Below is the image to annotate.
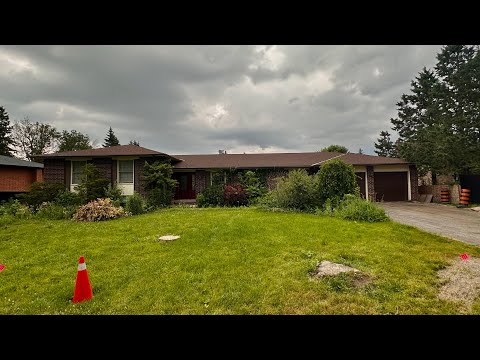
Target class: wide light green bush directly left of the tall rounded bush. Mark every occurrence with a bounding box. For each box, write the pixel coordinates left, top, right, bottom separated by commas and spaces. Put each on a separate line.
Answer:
261, 169, 318, 211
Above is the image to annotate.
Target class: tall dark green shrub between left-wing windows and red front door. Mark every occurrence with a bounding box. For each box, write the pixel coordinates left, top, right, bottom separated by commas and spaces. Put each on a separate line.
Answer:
143, 160, 177, 208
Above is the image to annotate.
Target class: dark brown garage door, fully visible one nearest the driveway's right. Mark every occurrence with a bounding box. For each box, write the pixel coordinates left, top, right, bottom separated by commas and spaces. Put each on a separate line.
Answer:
373, 171, 408, 201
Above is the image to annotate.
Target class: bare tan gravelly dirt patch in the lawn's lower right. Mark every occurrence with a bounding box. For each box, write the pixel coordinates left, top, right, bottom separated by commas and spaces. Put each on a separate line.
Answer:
438, 258, 480, 308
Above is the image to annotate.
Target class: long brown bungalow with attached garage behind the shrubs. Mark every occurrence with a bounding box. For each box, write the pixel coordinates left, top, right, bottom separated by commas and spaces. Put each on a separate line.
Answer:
36, 145, 418, 201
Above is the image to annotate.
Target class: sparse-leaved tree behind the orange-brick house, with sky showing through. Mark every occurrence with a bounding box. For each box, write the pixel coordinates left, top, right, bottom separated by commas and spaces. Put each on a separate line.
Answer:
12, 117, 60, 160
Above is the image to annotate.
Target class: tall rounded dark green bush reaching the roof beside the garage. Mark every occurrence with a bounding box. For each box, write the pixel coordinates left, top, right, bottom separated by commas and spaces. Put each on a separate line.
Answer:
314, 159, 360, 207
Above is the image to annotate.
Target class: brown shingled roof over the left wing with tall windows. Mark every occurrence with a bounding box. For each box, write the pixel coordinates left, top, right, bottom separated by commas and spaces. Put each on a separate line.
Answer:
35, 145, 180, 160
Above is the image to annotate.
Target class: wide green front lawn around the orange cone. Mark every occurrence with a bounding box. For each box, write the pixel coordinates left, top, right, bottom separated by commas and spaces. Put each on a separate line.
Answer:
0, 208, 480, 314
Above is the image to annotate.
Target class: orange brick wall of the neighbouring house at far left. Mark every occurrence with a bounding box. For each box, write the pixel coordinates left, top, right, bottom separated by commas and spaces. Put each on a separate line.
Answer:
0, 166, 42, 192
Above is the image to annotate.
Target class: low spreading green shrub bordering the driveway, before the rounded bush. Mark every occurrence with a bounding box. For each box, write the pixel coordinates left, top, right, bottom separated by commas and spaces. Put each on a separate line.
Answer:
317, 194, 389, 223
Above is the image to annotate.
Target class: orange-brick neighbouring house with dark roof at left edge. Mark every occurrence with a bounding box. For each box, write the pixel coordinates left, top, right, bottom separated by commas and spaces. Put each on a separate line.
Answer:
0, 155, 43, 200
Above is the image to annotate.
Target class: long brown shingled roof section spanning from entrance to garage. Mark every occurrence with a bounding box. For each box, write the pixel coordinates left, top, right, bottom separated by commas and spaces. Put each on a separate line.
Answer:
173, 152, 408, 169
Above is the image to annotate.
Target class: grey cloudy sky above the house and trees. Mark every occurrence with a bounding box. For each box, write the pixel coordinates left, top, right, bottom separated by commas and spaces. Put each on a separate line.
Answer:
0, 45, 441, 154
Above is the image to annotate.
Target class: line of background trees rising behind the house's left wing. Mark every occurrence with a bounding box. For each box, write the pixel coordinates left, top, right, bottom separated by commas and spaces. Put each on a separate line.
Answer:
0, 106, 140, 160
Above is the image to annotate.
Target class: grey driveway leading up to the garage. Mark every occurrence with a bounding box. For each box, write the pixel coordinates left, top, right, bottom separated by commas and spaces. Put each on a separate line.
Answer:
379, 202, 480, 245
